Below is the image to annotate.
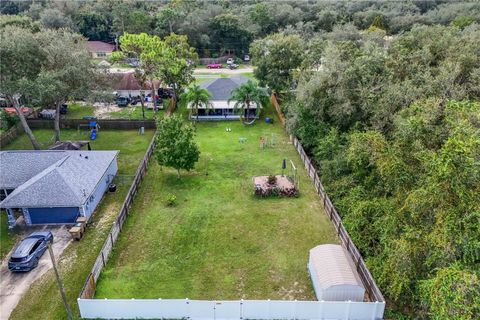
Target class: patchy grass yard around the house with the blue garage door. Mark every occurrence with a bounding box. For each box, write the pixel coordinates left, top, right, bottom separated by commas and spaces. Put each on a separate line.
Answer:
1, 130, 153, 319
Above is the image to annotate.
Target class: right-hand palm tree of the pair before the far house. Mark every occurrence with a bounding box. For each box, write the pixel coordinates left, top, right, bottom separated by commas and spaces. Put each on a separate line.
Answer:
228, 80, 268, 125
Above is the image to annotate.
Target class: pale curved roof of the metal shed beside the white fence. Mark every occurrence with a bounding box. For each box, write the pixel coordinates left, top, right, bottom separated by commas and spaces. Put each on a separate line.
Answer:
310, 244, 363, 289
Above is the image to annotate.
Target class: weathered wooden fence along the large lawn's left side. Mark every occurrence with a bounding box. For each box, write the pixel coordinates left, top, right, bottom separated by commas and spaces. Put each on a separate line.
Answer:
80, 136, 155, 299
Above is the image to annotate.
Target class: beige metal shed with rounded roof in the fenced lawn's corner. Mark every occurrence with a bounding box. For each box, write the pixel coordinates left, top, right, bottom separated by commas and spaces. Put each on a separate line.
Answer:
308, 244, 365, 301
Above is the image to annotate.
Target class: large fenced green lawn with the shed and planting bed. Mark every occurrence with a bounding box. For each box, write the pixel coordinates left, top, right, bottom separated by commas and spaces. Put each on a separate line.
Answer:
96, 107, 338, 299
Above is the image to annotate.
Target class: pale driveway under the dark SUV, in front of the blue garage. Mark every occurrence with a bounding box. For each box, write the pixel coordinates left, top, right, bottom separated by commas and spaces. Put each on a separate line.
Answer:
0, 226, 72, 320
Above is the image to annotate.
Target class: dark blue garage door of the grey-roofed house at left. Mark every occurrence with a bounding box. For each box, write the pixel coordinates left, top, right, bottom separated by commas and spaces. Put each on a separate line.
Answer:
26, 207, 80, 225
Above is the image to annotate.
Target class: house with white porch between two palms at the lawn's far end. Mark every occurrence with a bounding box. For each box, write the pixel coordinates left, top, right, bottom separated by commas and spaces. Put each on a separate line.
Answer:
188, 77, 257, 121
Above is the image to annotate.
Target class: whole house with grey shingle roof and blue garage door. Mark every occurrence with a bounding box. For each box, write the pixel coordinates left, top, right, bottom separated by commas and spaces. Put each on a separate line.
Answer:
0, 150, 118, 227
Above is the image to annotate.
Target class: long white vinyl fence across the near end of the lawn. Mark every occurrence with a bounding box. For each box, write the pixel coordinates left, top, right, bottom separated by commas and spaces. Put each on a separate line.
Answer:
78, 298, 385, 320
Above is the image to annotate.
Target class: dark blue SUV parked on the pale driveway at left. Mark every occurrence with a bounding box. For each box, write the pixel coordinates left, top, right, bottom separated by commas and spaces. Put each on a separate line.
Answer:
8, 231, 53, 272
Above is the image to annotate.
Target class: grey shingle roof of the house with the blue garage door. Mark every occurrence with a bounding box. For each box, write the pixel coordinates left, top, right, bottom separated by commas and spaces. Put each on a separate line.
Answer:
0, 150, 118, 208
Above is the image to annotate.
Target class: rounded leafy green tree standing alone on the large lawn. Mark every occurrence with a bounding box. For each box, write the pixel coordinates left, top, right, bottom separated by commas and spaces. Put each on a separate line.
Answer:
155, 115, 200, 177
